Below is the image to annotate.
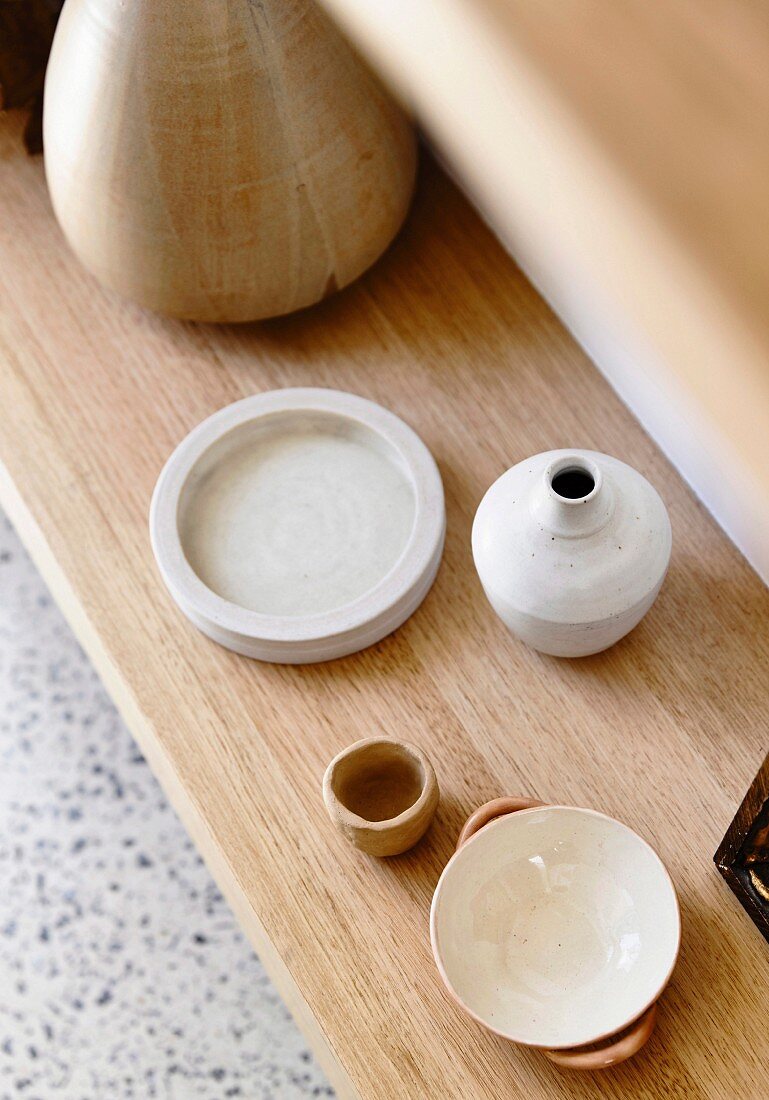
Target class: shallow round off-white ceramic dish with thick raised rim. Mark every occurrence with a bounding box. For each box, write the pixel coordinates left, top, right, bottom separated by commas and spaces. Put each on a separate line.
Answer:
150, 388, 446, 663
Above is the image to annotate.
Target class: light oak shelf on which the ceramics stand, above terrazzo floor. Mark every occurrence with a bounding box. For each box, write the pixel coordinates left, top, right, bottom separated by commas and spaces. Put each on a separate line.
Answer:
0, 109, 769, 1100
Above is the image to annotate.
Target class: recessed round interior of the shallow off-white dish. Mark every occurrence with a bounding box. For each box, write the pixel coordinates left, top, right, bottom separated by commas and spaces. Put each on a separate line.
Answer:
177, 409, 416, 617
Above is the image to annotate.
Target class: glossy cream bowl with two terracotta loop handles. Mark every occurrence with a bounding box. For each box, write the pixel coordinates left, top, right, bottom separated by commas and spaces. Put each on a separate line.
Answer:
430, 799, 681, 1069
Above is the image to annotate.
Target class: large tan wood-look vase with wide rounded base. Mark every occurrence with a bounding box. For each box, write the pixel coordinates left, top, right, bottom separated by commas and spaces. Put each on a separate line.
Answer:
44, 0, 416, 321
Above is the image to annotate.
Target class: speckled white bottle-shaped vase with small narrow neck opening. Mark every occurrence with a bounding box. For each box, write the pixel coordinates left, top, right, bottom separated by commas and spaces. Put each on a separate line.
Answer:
472, 450, 671, 657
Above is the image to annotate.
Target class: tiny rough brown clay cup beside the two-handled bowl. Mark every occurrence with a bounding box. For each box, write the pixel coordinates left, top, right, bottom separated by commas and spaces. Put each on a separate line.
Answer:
323, 737, 439, 856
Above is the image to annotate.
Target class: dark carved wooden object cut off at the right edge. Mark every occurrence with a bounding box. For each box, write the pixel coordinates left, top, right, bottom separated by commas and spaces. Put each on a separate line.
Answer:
713, 756, 769, 939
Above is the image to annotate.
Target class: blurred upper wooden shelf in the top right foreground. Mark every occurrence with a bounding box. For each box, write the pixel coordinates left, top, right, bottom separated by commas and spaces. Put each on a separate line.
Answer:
321, 0, 769, 578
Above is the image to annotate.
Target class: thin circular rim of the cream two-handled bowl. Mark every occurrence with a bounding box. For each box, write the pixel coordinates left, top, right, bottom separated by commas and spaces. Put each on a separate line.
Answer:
430, 803, 681, 1051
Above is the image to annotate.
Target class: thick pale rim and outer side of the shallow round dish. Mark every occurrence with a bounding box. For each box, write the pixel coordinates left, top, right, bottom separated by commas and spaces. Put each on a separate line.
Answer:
150, 386, 446, 662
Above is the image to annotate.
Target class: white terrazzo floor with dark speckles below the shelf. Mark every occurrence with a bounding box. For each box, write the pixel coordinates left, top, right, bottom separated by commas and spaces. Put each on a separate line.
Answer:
0, 514, 333, 1100
